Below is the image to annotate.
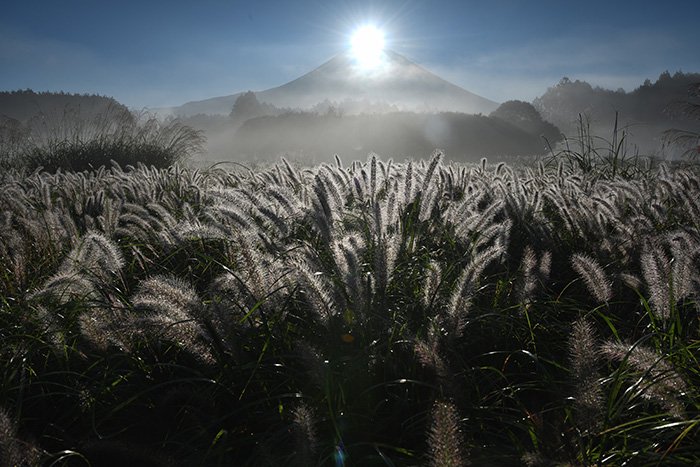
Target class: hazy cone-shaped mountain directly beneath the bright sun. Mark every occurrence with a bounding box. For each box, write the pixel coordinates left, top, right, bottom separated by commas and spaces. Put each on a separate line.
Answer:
162, 51, 498, 117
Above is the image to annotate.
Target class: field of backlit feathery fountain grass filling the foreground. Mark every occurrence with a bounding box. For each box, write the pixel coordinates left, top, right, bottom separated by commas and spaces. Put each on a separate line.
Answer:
0, 154, 700, 466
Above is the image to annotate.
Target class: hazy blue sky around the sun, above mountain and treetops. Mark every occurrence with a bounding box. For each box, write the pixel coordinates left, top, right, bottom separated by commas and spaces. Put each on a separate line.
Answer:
0, 0, 700, 108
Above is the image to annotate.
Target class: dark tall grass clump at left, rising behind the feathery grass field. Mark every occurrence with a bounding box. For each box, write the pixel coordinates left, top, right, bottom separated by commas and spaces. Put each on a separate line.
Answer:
0, 107, 204, 172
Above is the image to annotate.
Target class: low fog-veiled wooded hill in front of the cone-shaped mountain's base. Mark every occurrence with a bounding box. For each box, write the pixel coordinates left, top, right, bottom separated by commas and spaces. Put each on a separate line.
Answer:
201, 102, 559, 163
